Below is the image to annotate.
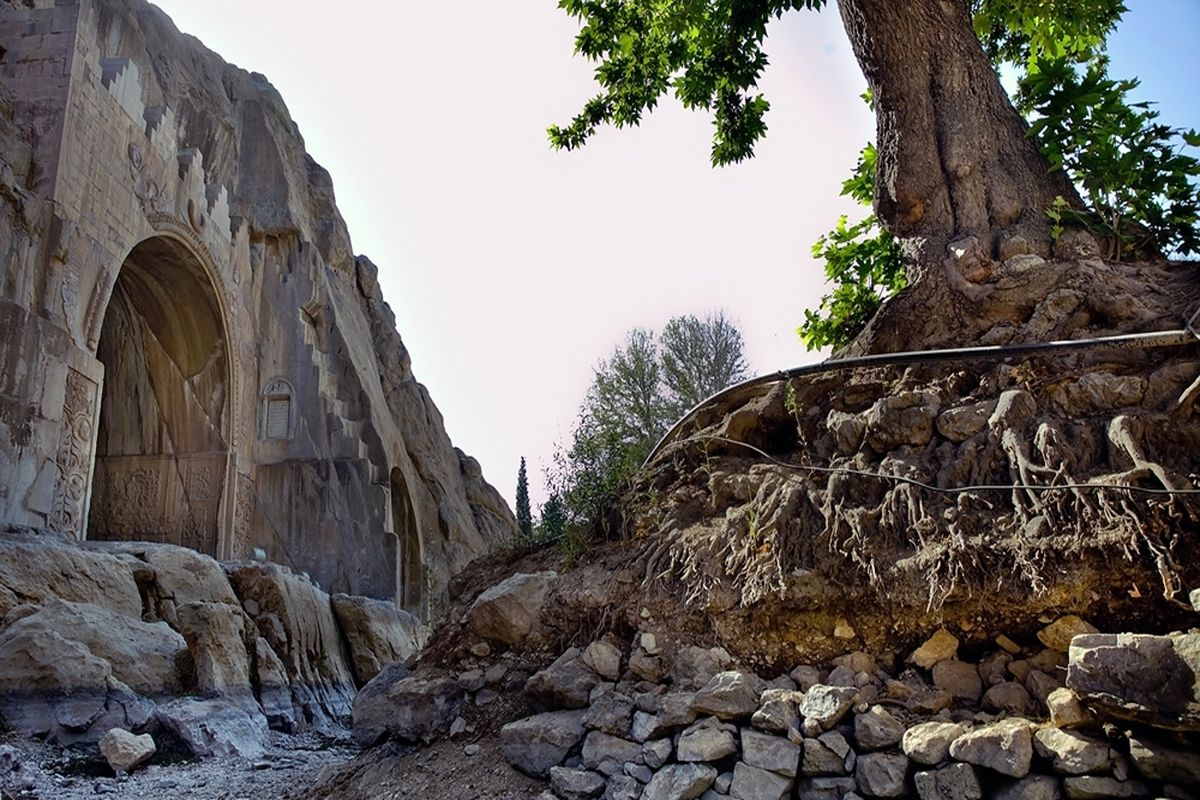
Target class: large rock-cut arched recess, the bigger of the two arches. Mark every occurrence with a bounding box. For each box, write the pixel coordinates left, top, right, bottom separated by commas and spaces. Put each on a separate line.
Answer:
88, 235, 232, 557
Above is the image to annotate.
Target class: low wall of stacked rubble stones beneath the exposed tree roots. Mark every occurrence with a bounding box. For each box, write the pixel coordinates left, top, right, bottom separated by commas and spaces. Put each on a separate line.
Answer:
354, 581, 1200, 800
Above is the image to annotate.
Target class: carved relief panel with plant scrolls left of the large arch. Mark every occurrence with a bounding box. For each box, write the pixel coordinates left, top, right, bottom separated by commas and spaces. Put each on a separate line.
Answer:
50, 369, 98, 539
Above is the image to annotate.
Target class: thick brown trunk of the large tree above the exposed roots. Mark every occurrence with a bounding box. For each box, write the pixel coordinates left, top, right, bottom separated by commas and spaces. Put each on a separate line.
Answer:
839, 0, 1076, 261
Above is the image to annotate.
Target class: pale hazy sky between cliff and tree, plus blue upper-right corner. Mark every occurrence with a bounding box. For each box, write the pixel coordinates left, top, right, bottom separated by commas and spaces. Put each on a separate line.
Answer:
157, 0, 1200, 513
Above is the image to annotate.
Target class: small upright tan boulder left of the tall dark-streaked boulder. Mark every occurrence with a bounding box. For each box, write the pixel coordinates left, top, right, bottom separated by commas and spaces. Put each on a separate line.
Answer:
175, 601, 258, 697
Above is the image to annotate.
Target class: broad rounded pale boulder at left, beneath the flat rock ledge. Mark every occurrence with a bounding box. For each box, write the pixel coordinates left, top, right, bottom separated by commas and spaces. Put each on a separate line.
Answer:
0, 597, 187, 697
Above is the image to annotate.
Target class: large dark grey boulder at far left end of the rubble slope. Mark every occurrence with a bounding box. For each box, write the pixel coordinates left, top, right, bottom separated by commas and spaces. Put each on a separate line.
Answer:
352, 670, 466, 746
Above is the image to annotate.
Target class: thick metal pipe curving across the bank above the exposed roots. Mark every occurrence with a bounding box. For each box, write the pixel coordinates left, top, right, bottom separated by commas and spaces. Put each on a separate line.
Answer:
642, 326, 1200, 469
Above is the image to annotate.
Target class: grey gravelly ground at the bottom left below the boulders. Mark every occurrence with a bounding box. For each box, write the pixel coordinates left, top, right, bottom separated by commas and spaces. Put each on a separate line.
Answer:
0, 732, 360, 800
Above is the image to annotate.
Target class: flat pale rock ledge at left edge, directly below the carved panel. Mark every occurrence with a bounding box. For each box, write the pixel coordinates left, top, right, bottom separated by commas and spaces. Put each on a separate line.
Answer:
0, 529, 142, 619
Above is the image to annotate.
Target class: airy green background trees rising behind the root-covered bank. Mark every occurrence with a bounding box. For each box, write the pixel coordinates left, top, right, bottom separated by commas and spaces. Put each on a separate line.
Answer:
544, 312, 748, 533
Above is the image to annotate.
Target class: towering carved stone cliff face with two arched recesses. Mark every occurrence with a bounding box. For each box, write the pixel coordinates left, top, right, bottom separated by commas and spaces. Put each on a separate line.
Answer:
0, 0, 515, 610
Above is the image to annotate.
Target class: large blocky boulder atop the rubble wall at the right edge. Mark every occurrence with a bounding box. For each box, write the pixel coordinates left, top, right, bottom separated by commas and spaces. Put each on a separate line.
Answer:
1067, 633, 1200, 730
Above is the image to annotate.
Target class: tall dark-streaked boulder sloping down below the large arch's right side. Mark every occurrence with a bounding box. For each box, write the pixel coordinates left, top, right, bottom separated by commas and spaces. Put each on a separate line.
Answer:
224, 563, 355, 728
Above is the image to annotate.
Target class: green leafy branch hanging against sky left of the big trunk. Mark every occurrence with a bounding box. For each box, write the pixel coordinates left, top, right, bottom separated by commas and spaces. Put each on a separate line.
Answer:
548, 0, 824, 164
